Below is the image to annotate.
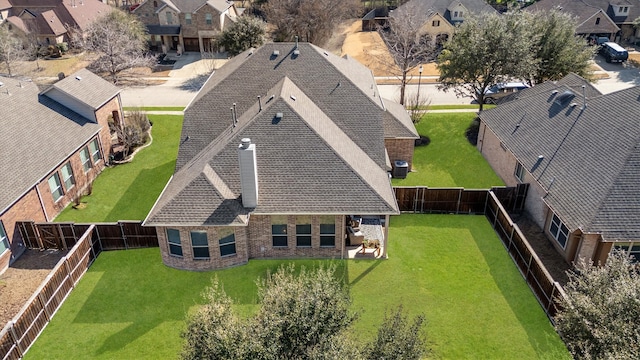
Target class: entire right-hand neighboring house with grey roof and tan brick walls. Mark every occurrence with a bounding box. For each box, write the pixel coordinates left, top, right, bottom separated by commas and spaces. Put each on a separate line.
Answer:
477, 74, 640, 263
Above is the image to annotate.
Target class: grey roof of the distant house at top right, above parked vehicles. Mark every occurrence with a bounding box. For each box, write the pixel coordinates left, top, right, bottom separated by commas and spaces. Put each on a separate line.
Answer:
525, 0, 624, 34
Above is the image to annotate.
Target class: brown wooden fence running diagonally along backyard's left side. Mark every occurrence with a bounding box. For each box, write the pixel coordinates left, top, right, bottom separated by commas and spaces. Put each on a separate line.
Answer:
0, 225, 98, 360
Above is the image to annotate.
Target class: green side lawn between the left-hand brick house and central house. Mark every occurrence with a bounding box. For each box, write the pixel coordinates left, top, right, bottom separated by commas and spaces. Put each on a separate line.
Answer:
55, 115, 182, 222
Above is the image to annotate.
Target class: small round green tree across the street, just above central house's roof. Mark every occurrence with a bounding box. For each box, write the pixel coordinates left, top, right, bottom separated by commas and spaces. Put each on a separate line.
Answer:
220, 16, 266, 56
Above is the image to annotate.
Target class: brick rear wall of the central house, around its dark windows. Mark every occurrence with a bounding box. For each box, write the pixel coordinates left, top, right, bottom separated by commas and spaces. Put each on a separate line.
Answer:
156, 215, 345, 271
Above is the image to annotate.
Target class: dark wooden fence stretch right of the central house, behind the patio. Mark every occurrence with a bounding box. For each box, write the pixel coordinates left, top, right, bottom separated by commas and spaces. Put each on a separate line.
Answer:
393, 184, 528, 214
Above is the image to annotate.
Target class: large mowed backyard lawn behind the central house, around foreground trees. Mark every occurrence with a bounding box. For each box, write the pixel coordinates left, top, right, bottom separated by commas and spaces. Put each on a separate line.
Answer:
25, 215, 570, 359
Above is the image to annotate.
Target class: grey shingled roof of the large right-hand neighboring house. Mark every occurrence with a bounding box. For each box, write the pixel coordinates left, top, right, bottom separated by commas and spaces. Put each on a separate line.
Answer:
480, 74, 640, 241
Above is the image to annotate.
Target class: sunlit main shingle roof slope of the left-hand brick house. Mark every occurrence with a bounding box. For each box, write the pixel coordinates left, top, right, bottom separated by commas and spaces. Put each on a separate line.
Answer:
0, 71, 117, 213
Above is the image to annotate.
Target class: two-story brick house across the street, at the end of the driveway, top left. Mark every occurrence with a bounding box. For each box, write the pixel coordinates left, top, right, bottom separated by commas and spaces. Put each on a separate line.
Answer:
133, 0, 239, 52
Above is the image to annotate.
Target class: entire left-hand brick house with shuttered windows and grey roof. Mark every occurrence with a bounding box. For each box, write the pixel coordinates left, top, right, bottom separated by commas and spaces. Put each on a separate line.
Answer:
0, 70, 122, 272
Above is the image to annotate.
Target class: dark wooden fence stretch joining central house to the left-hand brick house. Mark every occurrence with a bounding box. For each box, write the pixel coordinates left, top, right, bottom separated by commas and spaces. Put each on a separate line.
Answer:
16, 221, 158, 252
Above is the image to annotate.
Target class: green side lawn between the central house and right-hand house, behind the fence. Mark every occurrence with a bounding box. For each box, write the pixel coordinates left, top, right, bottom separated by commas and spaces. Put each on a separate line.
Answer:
392, 112, 504, 189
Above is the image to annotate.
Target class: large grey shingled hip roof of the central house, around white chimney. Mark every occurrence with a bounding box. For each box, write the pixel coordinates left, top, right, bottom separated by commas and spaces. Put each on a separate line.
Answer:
145, 43, 408, 226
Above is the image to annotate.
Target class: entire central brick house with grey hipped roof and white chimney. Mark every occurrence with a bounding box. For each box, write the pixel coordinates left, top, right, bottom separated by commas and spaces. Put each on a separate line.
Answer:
144, 43, 418, 270
